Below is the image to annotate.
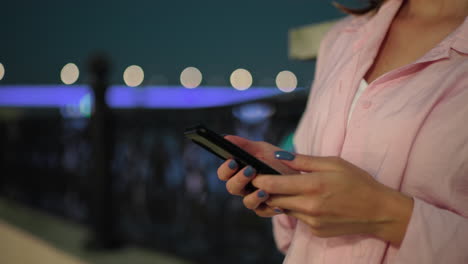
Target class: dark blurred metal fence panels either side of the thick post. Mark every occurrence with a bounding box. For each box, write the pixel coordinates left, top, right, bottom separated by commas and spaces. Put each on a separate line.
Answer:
0, 93, 305, 263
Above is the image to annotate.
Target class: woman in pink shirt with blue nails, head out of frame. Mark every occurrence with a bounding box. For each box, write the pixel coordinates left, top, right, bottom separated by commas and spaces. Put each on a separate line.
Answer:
218, 0, 468, 263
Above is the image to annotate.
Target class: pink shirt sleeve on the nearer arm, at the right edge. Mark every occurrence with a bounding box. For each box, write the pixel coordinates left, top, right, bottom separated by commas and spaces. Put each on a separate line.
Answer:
394, 75, 468, 264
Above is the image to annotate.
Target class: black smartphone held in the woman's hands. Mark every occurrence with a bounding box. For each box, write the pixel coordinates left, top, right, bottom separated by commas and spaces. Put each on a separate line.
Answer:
184, 125, 281, 191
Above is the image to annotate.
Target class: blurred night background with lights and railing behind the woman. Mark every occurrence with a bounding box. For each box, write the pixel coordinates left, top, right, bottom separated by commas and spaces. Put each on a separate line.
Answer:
0, 0, 343, 263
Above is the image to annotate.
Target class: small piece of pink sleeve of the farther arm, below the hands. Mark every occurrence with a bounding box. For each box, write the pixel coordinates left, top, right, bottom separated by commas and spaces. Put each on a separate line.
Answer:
273, 214, 297, 254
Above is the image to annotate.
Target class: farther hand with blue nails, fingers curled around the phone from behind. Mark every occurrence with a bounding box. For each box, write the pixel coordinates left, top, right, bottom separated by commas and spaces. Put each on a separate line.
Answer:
218, 136, 298, 217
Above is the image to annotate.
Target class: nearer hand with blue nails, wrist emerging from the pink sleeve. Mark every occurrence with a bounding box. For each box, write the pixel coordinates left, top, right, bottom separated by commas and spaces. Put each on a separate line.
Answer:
252, 151, 413, 246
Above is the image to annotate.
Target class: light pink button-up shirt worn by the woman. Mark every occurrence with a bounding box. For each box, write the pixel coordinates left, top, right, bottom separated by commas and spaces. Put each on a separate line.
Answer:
273, 0, 468, 264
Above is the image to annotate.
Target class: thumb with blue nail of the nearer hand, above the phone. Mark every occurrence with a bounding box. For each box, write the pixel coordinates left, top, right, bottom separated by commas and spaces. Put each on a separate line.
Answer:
275, 151, 339, 172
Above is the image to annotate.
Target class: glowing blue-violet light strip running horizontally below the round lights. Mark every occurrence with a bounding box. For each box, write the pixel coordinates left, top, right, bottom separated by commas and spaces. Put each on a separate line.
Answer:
0, 85, 283, 109
